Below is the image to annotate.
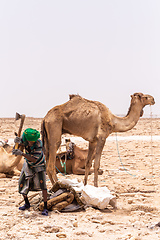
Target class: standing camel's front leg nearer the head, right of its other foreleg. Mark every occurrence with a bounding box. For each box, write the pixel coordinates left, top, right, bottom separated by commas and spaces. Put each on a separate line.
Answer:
94, 138, 106, 187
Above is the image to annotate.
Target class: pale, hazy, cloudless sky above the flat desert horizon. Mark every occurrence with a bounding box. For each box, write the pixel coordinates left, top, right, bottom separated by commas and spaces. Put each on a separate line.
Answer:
0, 0, 160, 117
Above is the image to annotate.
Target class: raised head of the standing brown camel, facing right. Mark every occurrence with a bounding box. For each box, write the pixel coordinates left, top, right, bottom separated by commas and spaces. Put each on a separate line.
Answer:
127, 93, 155, 117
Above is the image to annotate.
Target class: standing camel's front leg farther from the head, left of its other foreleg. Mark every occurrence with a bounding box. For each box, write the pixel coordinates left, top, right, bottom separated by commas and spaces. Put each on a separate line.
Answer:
84, 142, 97, 185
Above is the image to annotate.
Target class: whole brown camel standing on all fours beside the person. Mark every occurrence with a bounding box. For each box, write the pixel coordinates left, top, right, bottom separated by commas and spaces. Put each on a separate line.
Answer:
41, 93, 155, 187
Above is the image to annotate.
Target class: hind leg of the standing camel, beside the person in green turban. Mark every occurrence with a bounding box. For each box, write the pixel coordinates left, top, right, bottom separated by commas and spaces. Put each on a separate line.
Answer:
46, 121, 62, 184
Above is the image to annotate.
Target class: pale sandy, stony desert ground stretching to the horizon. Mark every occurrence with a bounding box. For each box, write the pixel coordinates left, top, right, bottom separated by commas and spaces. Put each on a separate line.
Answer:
0, 117, 160, 240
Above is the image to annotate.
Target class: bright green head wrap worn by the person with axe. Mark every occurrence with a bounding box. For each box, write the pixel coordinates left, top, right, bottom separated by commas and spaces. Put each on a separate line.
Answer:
22, 128, 40, 142
